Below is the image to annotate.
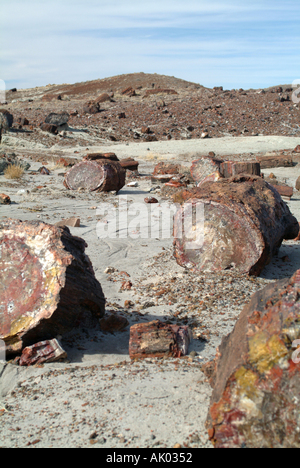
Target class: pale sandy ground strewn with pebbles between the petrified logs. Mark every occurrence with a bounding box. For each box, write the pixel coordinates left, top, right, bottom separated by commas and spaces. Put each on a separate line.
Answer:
0, 133, 300, 448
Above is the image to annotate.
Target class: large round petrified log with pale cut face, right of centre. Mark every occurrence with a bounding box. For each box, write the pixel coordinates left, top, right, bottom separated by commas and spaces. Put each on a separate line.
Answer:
174, 174, 299, 276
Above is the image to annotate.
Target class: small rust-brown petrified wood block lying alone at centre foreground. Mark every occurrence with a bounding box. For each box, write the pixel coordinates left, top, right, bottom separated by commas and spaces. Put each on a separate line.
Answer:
129, 320, 192, 359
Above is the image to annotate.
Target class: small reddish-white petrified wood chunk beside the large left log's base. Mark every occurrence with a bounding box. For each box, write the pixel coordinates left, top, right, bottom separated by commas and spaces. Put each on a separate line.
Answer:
19, 339, 68, 366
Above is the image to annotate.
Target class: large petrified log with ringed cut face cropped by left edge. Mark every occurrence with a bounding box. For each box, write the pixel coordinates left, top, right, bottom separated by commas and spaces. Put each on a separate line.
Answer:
0, 219, 105, 354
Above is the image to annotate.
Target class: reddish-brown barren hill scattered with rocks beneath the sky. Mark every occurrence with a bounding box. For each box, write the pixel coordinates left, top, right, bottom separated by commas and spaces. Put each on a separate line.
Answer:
3, 73, 300, 151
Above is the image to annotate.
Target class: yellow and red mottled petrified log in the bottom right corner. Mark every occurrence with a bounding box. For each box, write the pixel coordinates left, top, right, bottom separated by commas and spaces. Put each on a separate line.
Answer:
206, 270, 300, 448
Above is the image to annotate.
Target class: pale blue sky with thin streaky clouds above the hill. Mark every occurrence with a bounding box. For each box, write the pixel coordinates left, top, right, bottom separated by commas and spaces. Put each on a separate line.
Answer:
0, 0, 300, 89
